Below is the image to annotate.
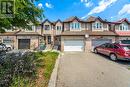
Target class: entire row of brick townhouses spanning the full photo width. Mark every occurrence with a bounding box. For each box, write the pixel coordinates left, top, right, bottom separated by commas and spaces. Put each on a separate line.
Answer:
0, 16, 130, 51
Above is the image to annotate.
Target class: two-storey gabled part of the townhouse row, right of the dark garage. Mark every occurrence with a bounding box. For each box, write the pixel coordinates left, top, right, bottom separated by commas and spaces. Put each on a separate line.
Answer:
42, 16, 130, 51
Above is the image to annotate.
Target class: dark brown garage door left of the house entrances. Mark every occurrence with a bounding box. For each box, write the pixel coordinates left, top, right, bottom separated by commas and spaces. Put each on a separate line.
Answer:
18, 39, 30, 49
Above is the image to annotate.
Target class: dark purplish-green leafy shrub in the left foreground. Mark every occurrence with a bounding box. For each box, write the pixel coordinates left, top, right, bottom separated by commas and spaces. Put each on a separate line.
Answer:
0, 52, 43, 87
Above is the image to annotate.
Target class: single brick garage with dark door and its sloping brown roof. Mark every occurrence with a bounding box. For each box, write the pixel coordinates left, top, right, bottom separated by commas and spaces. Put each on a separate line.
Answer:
16, 31, 41, 50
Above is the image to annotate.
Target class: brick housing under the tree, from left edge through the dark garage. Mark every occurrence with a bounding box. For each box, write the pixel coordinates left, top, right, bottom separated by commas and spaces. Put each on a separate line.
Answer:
0, 25, 42, 49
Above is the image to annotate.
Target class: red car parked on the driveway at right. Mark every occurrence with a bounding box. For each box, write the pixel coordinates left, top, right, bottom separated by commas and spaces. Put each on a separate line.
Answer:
94, 43, 130, 61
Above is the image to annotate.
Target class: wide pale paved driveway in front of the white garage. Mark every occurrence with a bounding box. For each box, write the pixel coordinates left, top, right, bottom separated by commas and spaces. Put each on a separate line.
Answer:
57, 52, 130, 87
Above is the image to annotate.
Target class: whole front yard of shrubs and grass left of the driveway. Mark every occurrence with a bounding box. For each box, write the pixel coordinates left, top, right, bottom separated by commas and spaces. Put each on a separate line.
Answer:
0, 51, 59, 87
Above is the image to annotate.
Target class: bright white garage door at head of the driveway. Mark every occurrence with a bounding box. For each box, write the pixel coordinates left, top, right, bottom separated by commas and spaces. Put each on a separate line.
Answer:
64, 40, 84, 51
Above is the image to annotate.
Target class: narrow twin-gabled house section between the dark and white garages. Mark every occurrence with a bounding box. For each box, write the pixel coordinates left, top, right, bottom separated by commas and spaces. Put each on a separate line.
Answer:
42, 19, 63, 45
